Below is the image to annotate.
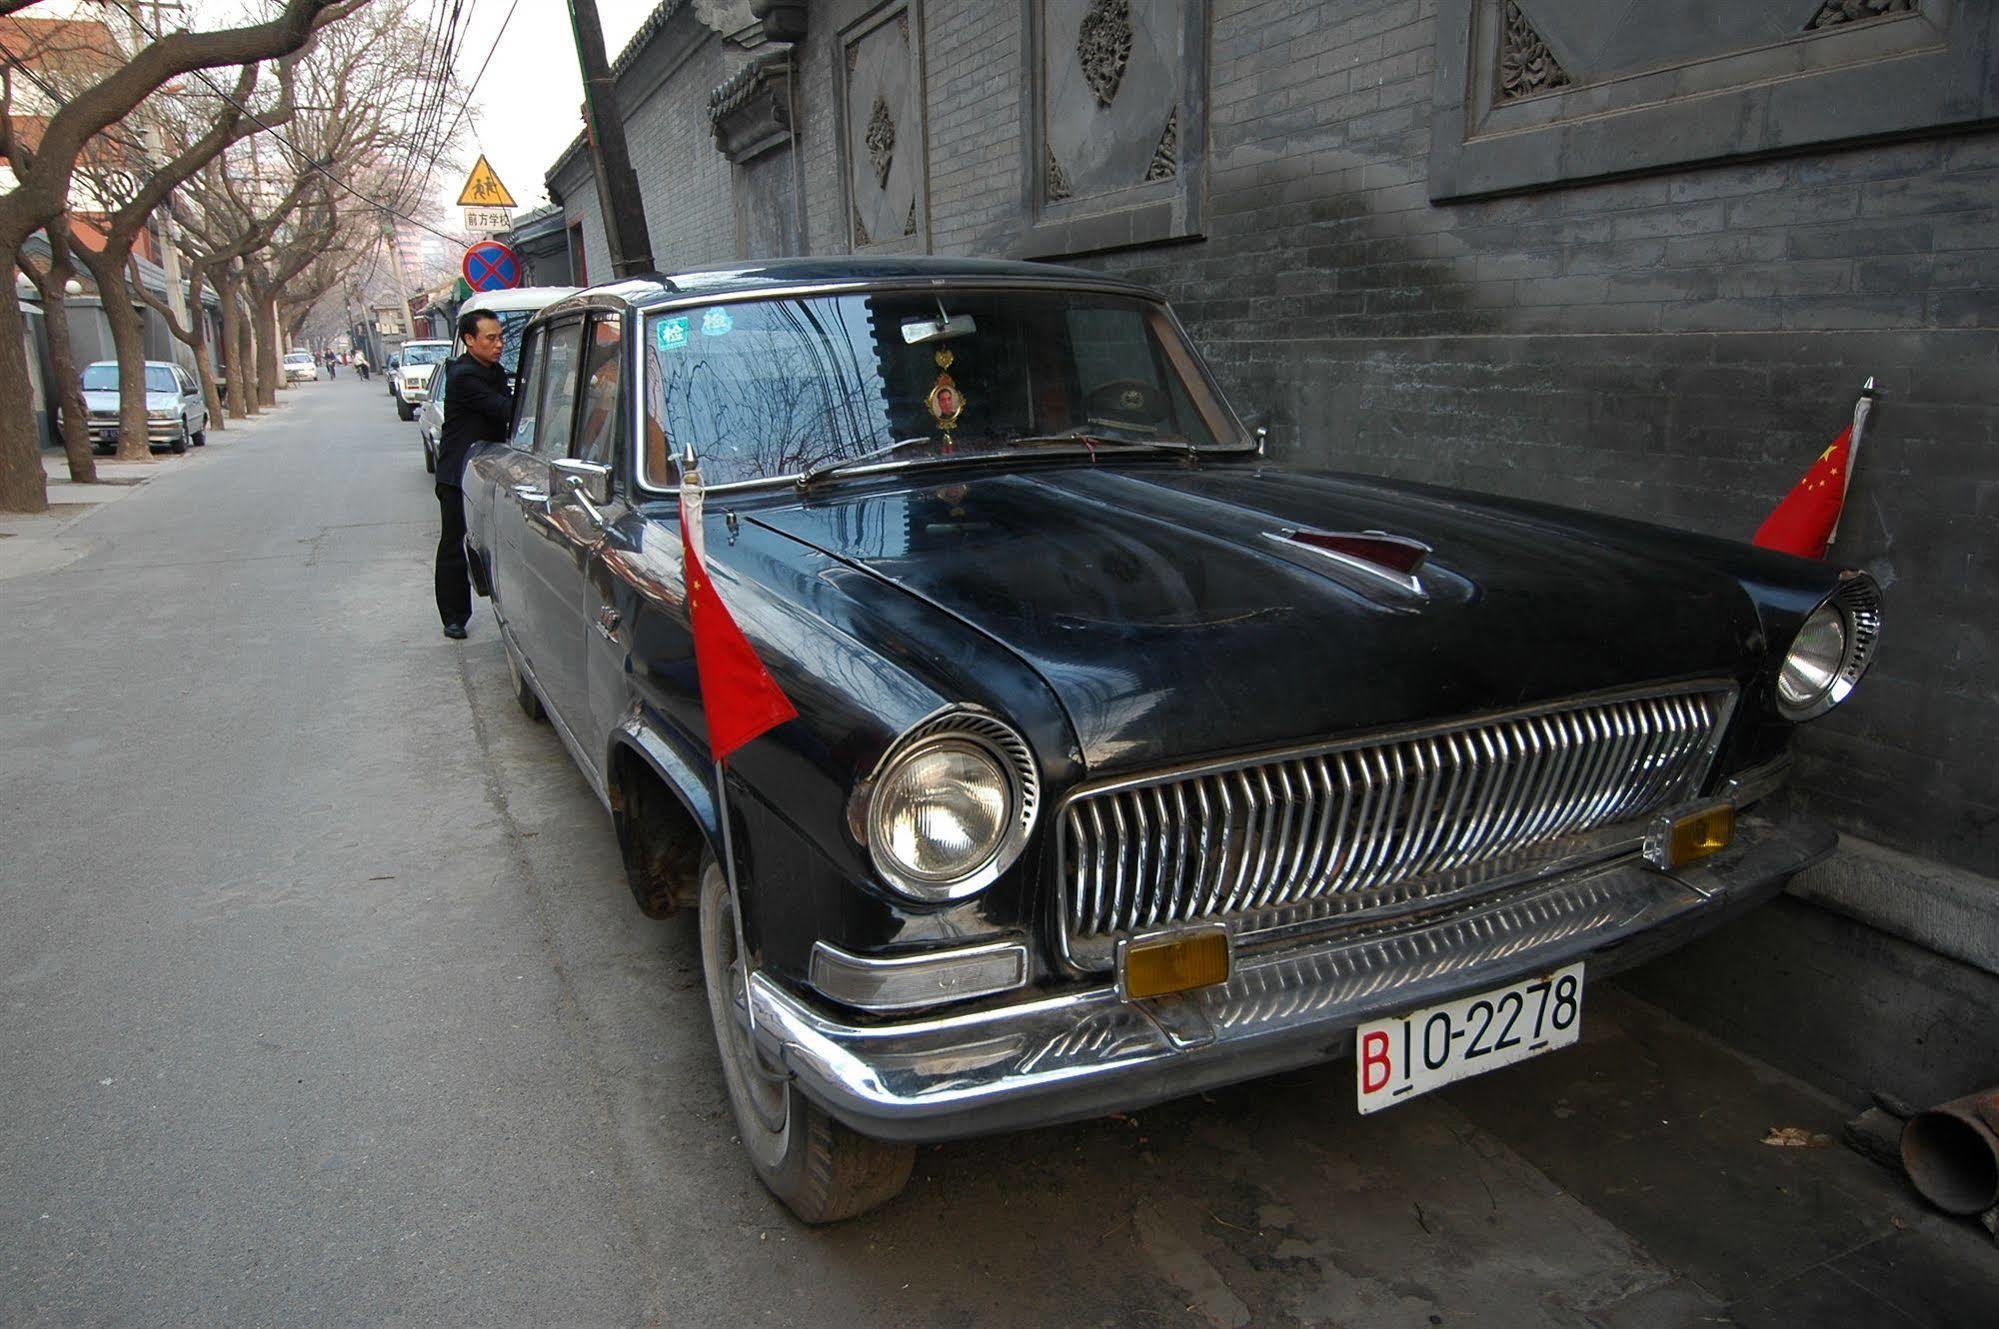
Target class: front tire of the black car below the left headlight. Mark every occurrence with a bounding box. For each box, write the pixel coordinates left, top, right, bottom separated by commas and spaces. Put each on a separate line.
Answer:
700, 855, 916, 1223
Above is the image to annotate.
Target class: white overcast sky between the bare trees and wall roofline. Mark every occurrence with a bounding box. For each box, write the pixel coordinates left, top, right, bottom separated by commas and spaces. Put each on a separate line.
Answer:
433, 0, 660, 228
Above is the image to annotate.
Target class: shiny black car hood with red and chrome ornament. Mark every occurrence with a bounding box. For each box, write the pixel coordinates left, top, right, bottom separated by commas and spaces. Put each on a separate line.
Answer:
756, 466, 1759, 771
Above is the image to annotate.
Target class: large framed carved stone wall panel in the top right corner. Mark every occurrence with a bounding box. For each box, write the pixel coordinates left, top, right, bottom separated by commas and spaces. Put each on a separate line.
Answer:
1427, 0, 1999, 202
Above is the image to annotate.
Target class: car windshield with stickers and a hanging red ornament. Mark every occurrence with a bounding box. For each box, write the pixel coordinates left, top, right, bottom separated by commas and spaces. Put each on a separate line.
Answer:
644, 290, 1243, 488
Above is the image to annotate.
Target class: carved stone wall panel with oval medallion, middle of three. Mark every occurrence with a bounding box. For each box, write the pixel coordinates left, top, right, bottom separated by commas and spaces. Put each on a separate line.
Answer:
1037, 0, 1189, 200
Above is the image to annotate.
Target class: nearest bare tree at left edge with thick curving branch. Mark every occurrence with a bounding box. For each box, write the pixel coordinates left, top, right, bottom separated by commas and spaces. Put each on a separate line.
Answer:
0, 0, 368, 512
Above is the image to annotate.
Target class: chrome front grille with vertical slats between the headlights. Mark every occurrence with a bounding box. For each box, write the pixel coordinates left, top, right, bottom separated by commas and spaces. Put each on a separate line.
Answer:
1057, 685, 1735, 963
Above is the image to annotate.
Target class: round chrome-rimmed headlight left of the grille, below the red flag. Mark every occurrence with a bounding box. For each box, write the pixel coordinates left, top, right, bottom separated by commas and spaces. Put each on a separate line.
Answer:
854, 711, 1039, 901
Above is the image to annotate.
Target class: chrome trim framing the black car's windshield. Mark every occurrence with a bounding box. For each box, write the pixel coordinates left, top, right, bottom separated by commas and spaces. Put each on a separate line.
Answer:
623, 276, 1259, 502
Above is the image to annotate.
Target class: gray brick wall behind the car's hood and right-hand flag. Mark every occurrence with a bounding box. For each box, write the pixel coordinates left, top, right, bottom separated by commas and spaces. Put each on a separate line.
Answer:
1075, 0, 1999, 875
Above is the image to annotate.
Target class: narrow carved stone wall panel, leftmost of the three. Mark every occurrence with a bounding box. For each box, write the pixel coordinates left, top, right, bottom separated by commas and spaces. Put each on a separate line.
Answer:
842, 6, 928, 250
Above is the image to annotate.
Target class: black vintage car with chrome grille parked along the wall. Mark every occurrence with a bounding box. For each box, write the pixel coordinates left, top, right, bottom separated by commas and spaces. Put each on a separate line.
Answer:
466, 260, 1879, 1221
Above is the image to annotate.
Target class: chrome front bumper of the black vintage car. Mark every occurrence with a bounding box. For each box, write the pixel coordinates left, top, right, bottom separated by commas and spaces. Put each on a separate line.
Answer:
750, 813, 1837, 1141
